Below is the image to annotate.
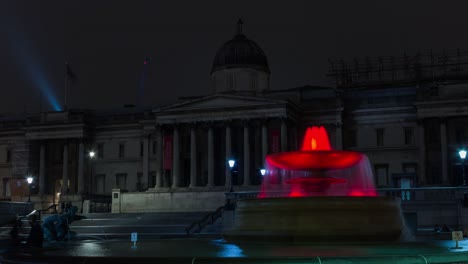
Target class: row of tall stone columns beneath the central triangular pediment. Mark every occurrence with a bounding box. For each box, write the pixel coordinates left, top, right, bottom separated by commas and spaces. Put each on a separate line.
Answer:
155, 119, 288, 188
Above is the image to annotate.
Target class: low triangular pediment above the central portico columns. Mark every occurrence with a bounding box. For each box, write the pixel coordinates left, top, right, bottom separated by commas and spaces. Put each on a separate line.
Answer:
155, 95, 286, 112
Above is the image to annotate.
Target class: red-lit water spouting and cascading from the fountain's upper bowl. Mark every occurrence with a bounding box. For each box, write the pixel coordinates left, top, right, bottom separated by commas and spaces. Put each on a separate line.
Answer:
259, 127, 377, 198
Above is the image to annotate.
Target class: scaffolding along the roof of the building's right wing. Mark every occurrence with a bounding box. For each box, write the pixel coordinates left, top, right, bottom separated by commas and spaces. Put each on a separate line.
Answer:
327, 49, 468, 88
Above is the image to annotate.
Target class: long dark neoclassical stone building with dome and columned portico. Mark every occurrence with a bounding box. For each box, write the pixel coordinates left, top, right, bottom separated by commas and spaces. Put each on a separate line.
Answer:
0, 23, 468, 226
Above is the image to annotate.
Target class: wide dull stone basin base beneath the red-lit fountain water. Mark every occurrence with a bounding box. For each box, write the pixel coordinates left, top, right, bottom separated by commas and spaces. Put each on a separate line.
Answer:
223, 196, 404, 242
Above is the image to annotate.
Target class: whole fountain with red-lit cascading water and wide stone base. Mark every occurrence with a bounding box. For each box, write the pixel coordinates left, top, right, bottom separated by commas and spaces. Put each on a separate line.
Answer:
224, 127, 404, 242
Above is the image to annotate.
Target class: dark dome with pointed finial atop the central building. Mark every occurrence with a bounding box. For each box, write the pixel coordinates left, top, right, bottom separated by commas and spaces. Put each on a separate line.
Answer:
211, 19, 270, 73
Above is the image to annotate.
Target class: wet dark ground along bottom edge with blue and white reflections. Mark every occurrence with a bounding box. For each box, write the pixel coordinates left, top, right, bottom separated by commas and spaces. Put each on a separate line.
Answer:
2, 237, 468, 263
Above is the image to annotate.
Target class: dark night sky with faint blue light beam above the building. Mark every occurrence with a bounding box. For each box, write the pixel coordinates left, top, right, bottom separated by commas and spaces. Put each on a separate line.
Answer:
0, 0, 468, 113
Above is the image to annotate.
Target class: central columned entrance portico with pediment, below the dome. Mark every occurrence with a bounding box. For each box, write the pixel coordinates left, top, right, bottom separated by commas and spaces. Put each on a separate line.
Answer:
154, 95, 295, 193
